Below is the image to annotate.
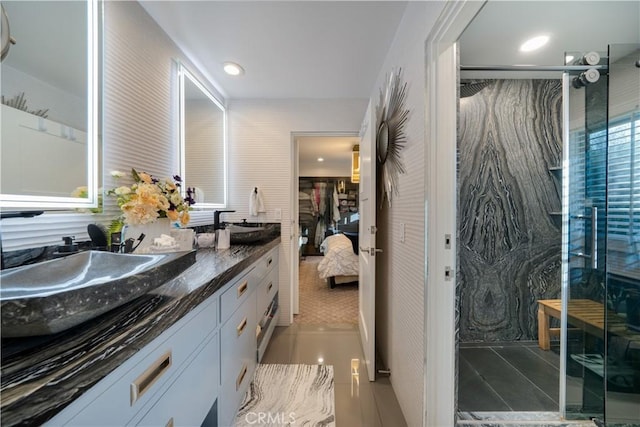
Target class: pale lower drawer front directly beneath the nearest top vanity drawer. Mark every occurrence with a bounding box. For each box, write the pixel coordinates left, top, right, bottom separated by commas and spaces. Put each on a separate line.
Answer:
136, 333, 220, 427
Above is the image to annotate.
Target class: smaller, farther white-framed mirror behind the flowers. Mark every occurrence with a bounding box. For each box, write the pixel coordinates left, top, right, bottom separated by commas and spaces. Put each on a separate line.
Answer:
179, 65, 227, 208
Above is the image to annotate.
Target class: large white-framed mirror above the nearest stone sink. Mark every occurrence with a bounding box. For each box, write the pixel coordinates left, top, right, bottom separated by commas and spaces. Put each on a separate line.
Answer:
0, 0, 98, 208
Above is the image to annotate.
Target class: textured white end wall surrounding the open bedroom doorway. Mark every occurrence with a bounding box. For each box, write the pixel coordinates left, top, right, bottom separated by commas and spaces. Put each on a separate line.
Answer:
227, 99, 367, 325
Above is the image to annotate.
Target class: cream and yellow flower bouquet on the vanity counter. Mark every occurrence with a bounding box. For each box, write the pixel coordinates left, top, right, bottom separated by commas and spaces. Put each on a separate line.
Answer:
107, 169, 195, 226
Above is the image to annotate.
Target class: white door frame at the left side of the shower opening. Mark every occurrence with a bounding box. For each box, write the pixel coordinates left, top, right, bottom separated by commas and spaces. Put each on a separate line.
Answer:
423, 0, 485, 426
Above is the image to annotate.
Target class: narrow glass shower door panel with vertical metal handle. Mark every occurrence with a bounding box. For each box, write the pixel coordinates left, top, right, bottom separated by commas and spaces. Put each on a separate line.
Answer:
562, 54, 608, 419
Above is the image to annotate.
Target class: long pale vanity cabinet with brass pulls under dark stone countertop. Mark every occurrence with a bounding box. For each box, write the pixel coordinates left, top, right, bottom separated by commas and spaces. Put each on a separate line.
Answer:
41, 246, 279, 427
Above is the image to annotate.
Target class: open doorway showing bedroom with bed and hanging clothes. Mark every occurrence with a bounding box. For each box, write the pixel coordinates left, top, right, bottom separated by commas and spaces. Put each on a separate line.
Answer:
293, 133, 359, 325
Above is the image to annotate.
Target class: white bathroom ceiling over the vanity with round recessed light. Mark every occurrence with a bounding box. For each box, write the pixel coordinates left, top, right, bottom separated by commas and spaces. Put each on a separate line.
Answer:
140, 0, 407, 99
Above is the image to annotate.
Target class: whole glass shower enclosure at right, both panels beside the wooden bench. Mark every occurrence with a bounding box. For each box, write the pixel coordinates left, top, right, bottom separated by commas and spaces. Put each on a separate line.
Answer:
558, 44, 640, 426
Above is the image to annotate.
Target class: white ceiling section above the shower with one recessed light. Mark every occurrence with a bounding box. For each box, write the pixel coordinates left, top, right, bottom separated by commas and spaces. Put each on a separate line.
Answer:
460, 0, 640, 78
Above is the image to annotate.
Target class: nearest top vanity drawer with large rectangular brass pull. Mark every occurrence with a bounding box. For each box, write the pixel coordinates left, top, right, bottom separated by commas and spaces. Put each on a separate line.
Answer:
50, 297, 217, 426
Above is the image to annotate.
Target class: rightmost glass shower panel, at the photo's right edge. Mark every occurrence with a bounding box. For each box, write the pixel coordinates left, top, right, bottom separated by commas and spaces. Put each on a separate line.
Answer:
604, 45, 640, 426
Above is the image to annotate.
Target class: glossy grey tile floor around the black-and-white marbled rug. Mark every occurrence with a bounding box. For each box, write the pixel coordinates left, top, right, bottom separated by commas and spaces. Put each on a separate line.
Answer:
261, 324, 406, 427
